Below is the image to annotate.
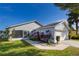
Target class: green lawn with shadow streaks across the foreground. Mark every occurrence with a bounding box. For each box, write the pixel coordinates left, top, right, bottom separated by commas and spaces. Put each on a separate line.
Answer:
0, 41, 79, 56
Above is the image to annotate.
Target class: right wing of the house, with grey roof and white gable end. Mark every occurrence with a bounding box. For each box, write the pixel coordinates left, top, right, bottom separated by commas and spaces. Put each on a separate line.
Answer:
35, 21, 68, 43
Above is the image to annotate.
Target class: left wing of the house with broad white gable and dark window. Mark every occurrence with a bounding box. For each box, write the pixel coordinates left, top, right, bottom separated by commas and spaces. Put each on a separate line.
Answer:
7, 21, 42, 40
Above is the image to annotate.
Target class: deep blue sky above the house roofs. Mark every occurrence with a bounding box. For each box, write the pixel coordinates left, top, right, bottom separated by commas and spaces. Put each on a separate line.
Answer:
0, 3, 67, 30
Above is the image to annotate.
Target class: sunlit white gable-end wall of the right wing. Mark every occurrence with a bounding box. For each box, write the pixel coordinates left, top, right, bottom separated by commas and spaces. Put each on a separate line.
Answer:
54, 23, 68, 42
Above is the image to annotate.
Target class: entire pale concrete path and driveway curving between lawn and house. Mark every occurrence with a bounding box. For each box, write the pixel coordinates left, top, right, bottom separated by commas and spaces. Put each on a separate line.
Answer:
25, 39, 79, 50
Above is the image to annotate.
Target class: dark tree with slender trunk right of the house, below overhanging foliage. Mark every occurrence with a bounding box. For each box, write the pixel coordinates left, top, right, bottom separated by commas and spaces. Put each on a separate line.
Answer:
68, 12, 79, 35
